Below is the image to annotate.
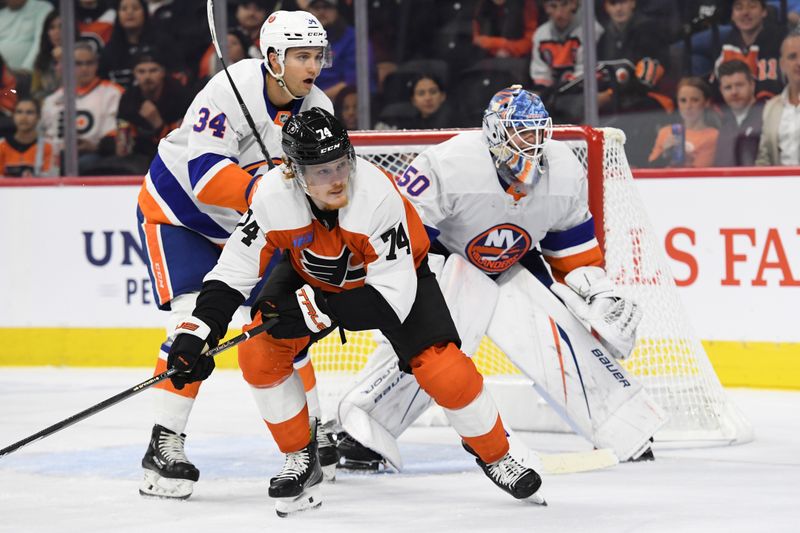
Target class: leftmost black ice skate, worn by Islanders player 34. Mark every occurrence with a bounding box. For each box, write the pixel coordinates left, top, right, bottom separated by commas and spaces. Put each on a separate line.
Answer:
139, 424, 200, 500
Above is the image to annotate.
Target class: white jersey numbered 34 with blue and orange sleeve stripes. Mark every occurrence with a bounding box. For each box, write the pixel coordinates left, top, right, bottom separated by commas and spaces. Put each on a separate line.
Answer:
139, 59, 333, 244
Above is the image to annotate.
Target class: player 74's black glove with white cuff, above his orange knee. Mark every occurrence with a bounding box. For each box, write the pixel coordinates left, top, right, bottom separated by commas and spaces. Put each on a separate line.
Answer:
260, 284, 334, 339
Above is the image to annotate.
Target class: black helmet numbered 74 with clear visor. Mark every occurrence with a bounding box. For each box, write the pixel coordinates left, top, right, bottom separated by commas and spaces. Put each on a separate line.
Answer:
281, 107, 356, 194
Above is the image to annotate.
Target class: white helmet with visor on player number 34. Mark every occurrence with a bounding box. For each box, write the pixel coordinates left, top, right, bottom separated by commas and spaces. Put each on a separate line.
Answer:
259, 11, 331, 83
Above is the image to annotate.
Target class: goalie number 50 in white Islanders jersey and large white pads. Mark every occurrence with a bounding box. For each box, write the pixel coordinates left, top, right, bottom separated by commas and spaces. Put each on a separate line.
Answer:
339, 85, 665, 469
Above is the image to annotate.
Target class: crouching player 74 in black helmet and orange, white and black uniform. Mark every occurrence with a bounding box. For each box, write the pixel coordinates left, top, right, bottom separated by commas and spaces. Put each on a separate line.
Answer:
169, 108, 543, 516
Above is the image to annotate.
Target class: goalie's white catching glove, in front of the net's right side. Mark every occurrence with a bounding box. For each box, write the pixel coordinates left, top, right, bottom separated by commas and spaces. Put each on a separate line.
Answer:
551, 267, 642, 359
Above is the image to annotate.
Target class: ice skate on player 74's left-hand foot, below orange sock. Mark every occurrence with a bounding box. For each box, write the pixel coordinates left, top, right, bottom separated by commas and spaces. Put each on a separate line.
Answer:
269, 419, 322, 518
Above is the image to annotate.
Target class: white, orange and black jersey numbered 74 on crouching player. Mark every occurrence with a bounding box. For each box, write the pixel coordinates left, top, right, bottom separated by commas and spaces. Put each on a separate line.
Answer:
204, 158, 430, 321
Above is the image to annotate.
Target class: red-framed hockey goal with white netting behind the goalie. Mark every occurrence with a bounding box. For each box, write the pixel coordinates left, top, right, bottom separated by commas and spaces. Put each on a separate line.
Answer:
311, 126, 752, 445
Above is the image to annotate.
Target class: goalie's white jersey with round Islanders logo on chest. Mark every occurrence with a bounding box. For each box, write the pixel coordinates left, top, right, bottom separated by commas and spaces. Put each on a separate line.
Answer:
406, 132, 602, 277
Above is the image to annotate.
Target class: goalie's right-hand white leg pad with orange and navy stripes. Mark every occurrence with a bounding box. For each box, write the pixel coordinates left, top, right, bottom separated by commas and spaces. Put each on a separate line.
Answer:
488, 266, 667, 461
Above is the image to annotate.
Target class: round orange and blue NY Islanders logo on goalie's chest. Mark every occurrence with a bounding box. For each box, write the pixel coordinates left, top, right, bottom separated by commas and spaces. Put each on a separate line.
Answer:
465, 224, 531, 274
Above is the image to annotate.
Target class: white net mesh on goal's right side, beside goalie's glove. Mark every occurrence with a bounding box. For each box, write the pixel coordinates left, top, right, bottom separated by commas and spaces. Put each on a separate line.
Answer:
603, 130, 751, 442
